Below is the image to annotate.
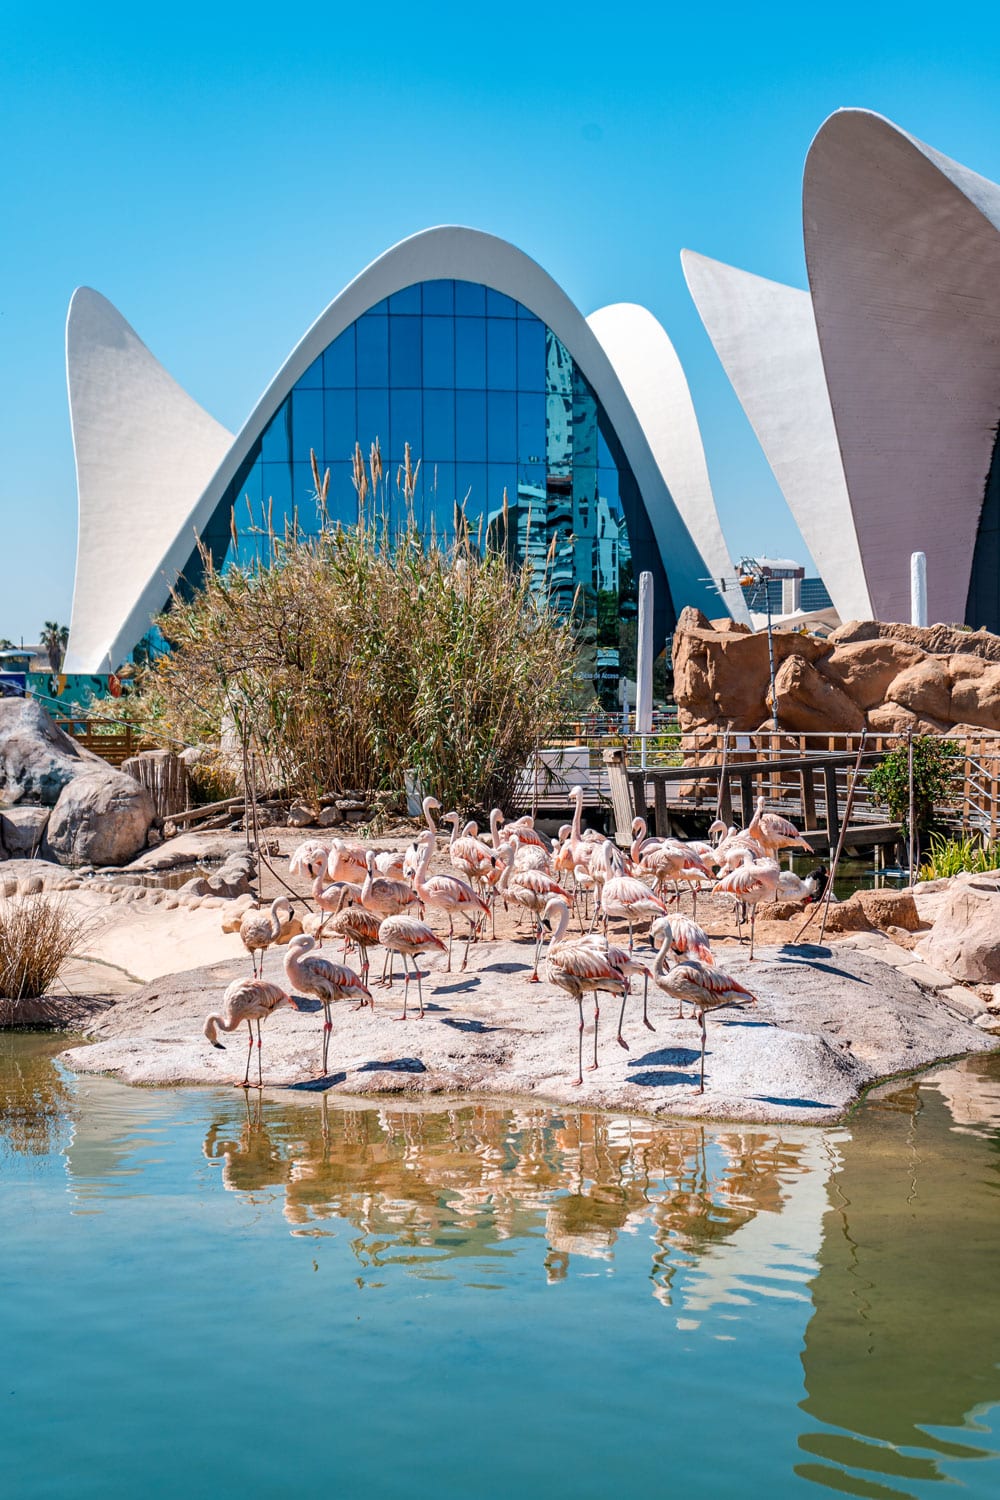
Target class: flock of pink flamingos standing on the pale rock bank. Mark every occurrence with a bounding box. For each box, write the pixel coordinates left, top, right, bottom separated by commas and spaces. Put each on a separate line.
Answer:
205, 788, 828, 1092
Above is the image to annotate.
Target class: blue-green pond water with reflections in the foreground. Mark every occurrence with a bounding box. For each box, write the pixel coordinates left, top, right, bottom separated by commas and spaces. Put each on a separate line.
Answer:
0, 1034, 1000, 1500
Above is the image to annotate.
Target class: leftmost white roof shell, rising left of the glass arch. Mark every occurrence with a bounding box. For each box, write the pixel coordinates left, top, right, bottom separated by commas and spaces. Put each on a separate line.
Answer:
64, 287, 232, 672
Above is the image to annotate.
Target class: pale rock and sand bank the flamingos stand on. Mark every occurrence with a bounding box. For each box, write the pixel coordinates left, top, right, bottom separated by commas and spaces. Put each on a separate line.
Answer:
3, 830, 997, 1124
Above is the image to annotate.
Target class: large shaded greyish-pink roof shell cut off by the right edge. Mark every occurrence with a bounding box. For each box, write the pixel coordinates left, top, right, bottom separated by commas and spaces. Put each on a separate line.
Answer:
802, 110, 1000, 621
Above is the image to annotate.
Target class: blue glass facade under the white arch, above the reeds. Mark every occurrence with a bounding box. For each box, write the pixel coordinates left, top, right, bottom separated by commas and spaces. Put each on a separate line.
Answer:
184, 281, 675, 707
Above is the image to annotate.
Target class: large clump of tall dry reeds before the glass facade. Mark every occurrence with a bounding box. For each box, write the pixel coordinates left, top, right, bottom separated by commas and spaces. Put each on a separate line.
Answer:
111, 446, 574, 807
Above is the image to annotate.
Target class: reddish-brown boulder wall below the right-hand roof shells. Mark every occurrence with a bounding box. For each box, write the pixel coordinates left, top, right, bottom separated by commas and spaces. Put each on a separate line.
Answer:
673, 608, 1000, 735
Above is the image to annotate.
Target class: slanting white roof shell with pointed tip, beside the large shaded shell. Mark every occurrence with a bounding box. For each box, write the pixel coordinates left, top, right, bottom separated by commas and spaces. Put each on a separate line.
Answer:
681, 251, 871, 620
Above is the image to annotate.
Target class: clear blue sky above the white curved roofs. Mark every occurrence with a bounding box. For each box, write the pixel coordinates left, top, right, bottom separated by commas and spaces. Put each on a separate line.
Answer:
0, 0, 1000, 639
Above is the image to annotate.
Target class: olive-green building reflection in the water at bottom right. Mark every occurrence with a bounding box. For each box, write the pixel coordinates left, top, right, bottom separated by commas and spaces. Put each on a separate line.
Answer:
798, 1059, 1000, 1496
